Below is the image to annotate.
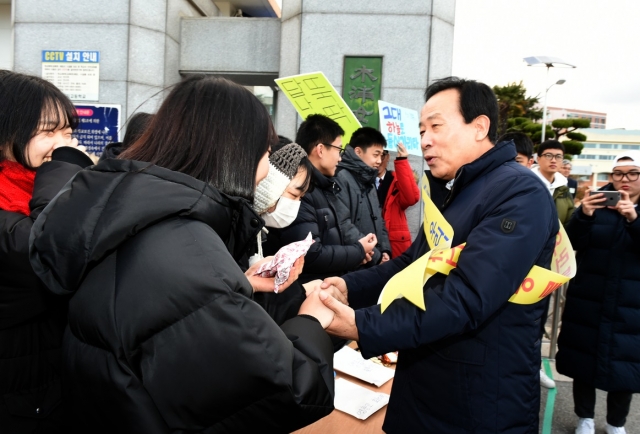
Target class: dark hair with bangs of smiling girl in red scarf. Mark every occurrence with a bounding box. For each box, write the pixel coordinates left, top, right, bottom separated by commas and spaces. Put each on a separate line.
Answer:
0, 70, 78, 169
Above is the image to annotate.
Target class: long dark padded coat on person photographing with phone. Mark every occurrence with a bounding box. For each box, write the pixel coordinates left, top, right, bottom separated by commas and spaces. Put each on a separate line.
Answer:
557, 184, 640, 393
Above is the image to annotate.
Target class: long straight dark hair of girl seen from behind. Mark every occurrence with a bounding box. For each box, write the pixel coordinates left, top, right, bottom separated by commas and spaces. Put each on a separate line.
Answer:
118, 76, 278, 201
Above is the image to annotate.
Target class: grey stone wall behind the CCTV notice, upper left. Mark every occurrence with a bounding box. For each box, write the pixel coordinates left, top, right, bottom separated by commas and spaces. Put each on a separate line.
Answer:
13, 0, 217, 123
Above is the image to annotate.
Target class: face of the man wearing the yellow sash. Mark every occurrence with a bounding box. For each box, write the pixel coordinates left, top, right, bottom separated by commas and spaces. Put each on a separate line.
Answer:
420, 89, 486, 181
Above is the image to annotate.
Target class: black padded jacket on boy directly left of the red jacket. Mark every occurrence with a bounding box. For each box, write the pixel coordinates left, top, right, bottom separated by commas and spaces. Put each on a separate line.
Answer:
336, 146, 391, 266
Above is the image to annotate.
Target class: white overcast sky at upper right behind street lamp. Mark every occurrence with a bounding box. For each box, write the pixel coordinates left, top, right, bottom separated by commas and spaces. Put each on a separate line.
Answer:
452, 0, 640, 130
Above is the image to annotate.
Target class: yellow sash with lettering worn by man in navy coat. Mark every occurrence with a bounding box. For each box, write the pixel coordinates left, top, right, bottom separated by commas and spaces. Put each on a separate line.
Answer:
378, 175, 577, 312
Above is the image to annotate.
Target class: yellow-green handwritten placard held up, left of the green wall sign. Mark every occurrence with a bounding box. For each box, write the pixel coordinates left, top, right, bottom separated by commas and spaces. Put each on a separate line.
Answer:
275, 72, 362, 146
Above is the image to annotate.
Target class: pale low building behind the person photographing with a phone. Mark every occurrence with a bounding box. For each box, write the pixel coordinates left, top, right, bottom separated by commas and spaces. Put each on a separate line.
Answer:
571, 124, 640, 187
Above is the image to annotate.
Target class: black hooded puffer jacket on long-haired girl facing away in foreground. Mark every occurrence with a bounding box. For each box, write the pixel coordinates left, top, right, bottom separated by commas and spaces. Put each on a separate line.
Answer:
31, 160, 333, 433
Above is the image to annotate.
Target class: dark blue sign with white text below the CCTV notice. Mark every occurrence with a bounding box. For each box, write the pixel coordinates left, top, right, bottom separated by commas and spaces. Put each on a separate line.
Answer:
73, 104, 122, 156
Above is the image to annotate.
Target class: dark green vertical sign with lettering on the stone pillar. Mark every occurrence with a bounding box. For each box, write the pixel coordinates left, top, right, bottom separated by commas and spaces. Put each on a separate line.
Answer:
342, 56, 382, 129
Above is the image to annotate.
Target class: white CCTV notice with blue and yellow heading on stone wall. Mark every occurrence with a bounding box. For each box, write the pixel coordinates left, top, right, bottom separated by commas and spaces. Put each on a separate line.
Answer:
42, 50, 100, 101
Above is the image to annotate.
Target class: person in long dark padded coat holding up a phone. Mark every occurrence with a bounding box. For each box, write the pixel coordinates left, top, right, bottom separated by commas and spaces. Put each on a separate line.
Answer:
556, 151, 640, 434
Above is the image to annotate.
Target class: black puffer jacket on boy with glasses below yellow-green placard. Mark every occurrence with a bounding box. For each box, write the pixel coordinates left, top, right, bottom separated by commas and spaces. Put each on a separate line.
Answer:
280, 164, 365, 283
